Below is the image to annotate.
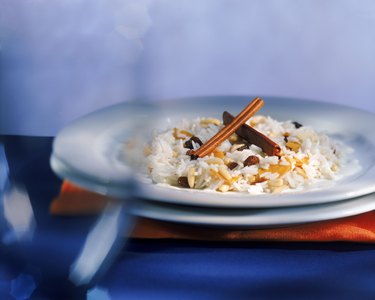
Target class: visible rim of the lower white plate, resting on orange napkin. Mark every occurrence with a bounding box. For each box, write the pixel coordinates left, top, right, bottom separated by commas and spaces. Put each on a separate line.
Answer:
133, 194, 375, 228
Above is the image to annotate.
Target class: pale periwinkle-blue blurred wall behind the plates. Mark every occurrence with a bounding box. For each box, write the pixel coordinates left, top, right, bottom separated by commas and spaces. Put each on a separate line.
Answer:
0, 0, 375, 135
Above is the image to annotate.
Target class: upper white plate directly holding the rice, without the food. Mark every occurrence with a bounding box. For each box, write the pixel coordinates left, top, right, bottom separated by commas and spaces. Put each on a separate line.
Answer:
51, 96, 375, 208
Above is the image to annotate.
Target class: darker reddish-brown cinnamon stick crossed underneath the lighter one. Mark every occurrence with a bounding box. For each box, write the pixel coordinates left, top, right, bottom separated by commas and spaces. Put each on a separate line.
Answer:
223, 111, 281, 156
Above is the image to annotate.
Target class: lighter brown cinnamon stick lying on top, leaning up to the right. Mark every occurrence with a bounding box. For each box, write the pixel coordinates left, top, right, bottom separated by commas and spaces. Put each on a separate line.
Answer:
190, 97, 264, 157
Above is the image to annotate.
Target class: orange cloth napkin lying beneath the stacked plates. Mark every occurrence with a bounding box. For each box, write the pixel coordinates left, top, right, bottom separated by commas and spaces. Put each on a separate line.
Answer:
50, 181, 375, 243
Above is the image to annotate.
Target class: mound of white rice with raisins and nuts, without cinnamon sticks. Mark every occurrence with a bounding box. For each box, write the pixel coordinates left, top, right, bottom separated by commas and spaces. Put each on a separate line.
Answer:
146, 115, 343, 194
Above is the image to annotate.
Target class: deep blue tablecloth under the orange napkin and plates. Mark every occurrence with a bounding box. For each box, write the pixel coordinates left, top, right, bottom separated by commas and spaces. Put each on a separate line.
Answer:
0, 136, 375, 300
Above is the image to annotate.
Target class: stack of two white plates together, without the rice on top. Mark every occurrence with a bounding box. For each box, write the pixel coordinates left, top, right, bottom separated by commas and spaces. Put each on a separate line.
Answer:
51, 96, 375, 227
